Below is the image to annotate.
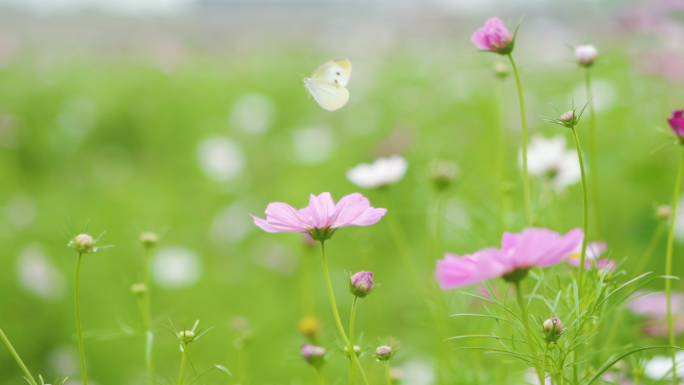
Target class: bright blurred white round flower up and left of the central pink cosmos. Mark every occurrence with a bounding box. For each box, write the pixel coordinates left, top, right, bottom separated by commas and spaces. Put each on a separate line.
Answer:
197, 136, 245, 182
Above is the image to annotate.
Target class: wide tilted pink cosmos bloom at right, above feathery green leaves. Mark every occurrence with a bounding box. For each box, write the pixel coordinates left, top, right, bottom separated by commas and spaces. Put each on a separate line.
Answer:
435, 228, 584, 289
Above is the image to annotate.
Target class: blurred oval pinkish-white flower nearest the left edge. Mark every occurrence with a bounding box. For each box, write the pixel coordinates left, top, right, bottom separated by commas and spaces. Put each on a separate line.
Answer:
17, 244, 65, 301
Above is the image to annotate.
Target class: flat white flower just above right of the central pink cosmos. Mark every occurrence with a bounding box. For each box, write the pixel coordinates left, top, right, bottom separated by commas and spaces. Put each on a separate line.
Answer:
347, 155, 408, 188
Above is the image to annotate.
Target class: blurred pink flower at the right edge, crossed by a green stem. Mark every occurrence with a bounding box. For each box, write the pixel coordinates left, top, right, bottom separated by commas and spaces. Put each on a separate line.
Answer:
627, 291, 684, 336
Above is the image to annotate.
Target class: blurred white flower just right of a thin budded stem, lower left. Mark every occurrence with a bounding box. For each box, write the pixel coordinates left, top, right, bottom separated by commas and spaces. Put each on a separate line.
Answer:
152, 246, 202, 289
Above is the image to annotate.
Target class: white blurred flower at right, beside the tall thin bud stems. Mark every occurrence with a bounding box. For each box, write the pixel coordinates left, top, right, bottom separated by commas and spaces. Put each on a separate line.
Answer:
520, 135, 582, 190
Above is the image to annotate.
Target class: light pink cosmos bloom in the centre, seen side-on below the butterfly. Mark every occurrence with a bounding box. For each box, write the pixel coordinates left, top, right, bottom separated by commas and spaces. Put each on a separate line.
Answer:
250, 192, 387, 241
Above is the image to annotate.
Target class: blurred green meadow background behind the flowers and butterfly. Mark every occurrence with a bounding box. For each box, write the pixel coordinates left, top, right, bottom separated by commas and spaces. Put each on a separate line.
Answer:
0, 2, 684, 385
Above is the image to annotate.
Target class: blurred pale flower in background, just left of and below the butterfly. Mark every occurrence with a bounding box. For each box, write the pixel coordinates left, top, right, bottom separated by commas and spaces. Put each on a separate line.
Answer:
228, 93, 276, 134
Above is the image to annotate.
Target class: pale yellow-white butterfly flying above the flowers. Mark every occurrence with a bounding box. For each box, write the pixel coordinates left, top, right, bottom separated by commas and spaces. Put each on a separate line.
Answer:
304, 59, 351, 111
